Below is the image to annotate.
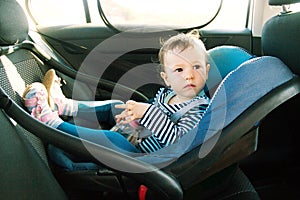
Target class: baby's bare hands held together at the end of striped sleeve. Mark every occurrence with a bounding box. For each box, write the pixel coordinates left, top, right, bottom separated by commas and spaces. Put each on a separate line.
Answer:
115, 100, 150, 123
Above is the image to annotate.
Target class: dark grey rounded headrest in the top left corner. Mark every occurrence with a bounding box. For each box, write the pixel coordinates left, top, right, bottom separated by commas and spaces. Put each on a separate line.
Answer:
0, 0, 28, 46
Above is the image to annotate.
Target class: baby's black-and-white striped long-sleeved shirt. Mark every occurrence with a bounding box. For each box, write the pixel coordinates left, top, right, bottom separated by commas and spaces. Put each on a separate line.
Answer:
137, 88, 209, 153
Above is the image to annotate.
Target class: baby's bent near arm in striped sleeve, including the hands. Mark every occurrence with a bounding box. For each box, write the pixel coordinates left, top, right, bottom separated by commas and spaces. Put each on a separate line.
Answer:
116, 101, 207, 145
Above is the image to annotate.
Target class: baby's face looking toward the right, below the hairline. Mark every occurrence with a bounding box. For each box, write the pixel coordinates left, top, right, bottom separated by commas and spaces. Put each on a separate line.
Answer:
161, 45, 210, 100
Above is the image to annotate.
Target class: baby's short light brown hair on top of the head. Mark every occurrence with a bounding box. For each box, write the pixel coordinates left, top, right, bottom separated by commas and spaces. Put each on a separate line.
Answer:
158, 29, 206, 71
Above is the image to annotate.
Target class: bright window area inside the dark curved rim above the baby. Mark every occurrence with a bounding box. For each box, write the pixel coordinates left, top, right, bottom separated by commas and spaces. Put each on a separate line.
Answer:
100, 0, 221, 30
